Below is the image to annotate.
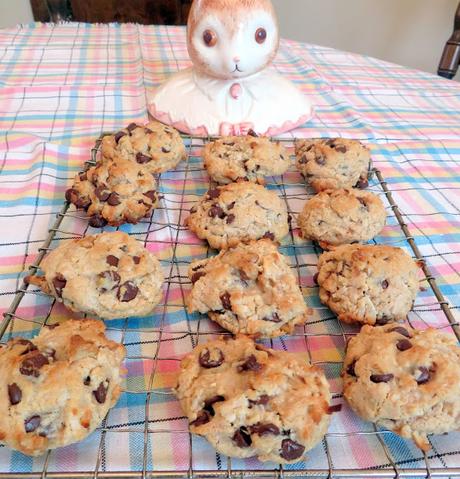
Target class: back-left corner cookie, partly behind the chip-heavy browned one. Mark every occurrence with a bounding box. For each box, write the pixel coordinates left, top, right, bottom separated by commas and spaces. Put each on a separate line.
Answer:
101, 121, 187, 173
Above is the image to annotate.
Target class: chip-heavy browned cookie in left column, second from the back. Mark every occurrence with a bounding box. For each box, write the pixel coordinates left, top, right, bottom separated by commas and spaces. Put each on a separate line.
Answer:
66, 158, 158, 228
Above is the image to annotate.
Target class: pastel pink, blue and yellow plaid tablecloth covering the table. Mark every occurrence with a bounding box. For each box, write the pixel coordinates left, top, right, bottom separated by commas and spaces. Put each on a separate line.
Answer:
0, 24, 460, 473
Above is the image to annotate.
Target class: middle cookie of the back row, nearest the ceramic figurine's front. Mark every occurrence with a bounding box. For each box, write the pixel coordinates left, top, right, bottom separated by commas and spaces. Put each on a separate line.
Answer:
203, 136, 291, 184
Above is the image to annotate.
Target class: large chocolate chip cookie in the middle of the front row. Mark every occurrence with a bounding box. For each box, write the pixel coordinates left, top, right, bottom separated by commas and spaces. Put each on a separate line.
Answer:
176, 336, 331, 463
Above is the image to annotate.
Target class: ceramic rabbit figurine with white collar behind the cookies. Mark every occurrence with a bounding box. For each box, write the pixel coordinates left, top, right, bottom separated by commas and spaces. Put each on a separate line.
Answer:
149, 0, 311, 136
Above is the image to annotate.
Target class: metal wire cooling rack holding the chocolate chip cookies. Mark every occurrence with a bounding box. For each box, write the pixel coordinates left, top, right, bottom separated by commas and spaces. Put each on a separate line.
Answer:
0, 137, 460, 478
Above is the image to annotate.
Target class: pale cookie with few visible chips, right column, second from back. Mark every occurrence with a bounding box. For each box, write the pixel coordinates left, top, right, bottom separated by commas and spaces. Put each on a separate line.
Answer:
297, 189, 387, 249
